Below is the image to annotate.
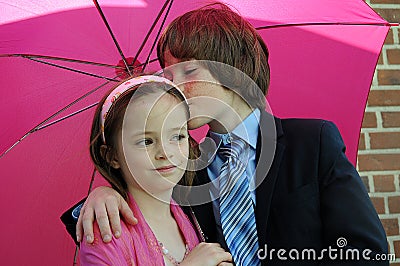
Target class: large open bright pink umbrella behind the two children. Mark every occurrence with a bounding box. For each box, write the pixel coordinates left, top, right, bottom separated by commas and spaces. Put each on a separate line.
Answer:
0, 0, 390, 265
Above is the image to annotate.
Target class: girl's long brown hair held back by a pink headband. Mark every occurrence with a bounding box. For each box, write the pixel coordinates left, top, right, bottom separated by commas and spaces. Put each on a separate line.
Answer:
90, 81, 197, 199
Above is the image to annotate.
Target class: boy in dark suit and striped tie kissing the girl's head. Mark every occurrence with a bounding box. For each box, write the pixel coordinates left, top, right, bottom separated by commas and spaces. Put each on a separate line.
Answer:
71, 4, 388, 265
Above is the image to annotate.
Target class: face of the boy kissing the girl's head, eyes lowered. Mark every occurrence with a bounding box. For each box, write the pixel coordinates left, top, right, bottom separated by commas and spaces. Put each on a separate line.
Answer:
164, 50, 238, 129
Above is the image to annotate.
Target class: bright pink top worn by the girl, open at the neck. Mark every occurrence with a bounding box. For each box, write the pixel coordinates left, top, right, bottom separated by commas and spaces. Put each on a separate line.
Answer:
80, 195, 199, 266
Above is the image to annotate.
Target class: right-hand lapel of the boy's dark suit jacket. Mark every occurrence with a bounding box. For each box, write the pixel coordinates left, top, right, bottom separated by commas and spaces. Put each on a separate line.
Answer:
255, 111, 285, 248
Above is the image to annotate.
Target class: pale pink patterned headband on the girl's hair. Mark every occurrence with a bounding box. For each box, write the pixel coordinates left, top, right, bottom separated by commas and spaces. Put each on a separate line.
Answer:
100, 75, 186, 143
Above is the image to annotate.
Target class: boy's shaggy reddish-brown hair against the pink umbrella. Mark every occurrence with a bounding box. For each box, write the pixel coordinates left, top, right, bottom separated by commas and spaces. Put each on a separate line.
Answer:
157, 3, 270, 109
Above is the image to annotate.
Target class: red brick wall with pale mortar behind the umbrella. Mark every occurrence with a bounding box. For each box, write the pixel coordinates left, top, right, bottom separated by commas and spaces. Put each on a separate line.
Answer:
358, 0, 400, 266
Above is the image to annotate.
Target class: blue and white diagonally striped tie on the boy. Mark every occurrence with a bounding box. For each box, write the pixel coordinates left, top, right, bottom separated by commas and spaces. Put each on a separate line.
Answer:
218, 138, 260, 266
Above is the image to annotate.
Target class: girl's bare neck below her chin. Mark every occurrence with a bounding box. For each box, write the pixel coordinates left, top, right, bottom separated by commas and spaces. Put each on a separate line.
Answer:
129, 188, 173, 222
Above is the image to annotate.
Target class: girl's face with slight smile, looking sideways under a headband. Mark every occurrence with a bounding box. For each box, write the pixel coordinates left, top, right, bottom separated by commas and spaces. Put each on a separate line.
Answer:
117, 93, 189, 194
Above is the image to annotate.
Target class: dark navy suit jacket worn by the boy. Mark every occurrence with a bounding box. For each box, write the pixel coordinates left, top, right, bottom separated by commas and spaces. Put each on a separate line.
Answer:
180, 112, 389, 266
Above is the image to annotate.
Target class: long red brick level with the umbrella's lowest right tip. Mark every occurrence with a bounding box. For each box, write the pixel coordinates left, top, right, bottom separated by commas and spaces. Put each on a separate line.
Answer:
358, 154, 400, 171
